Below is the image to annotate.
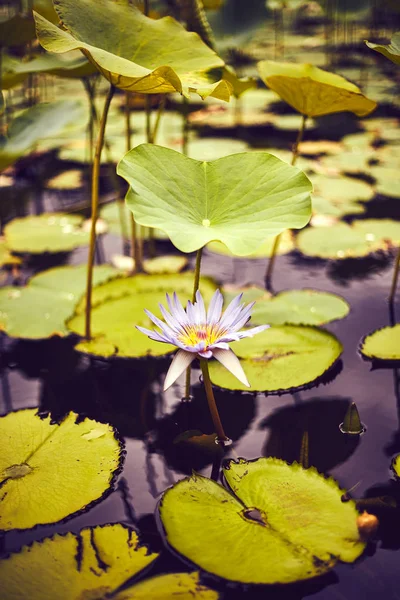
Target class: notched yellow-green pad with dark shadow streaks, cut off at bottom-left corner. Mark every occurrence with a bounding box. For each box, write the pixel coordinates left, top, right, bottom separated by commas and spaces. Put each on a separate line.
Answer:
0, 523, 218, 600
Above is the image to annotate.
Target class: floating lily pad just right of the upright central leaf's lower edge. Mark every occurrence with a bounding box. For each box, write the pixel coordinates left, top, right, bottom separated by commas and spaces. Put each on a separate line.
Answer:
296, 223, 382, 260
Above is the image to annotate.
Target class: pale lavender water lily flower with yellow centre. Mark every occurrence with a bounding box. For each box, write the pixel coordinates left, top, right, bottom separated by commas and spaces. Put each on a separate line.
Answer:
137, 290, 269, 391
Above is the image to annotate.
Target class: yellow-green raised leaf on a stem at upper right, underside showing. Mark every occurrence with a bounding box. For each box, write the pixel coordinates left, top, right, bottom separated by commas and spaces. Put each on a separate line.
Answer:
258, 60, 376, 117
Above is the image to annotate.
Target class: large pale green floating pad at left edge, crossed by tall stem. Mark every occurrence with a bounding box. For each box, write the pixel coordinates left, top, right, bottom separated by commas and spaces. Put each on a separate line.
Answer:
0, 265, 119, 339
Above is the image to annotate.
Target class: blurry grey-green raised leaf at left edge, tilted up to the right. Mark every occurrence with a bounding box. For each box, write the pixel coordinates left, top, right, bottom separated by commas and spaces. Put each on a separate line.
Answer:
0, 100, 84, 171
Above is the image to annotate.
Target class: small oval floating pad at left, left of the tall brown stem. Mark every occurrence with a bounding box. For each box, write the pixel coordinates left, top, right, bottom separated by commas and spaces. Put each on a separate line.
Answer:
4, 213, 89, 254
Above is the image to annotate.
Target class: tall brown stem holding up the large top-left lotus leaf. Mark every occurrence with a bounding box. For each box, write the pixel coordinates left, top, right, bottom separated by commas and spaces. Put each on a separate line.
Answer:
85, 85, 115, 340
